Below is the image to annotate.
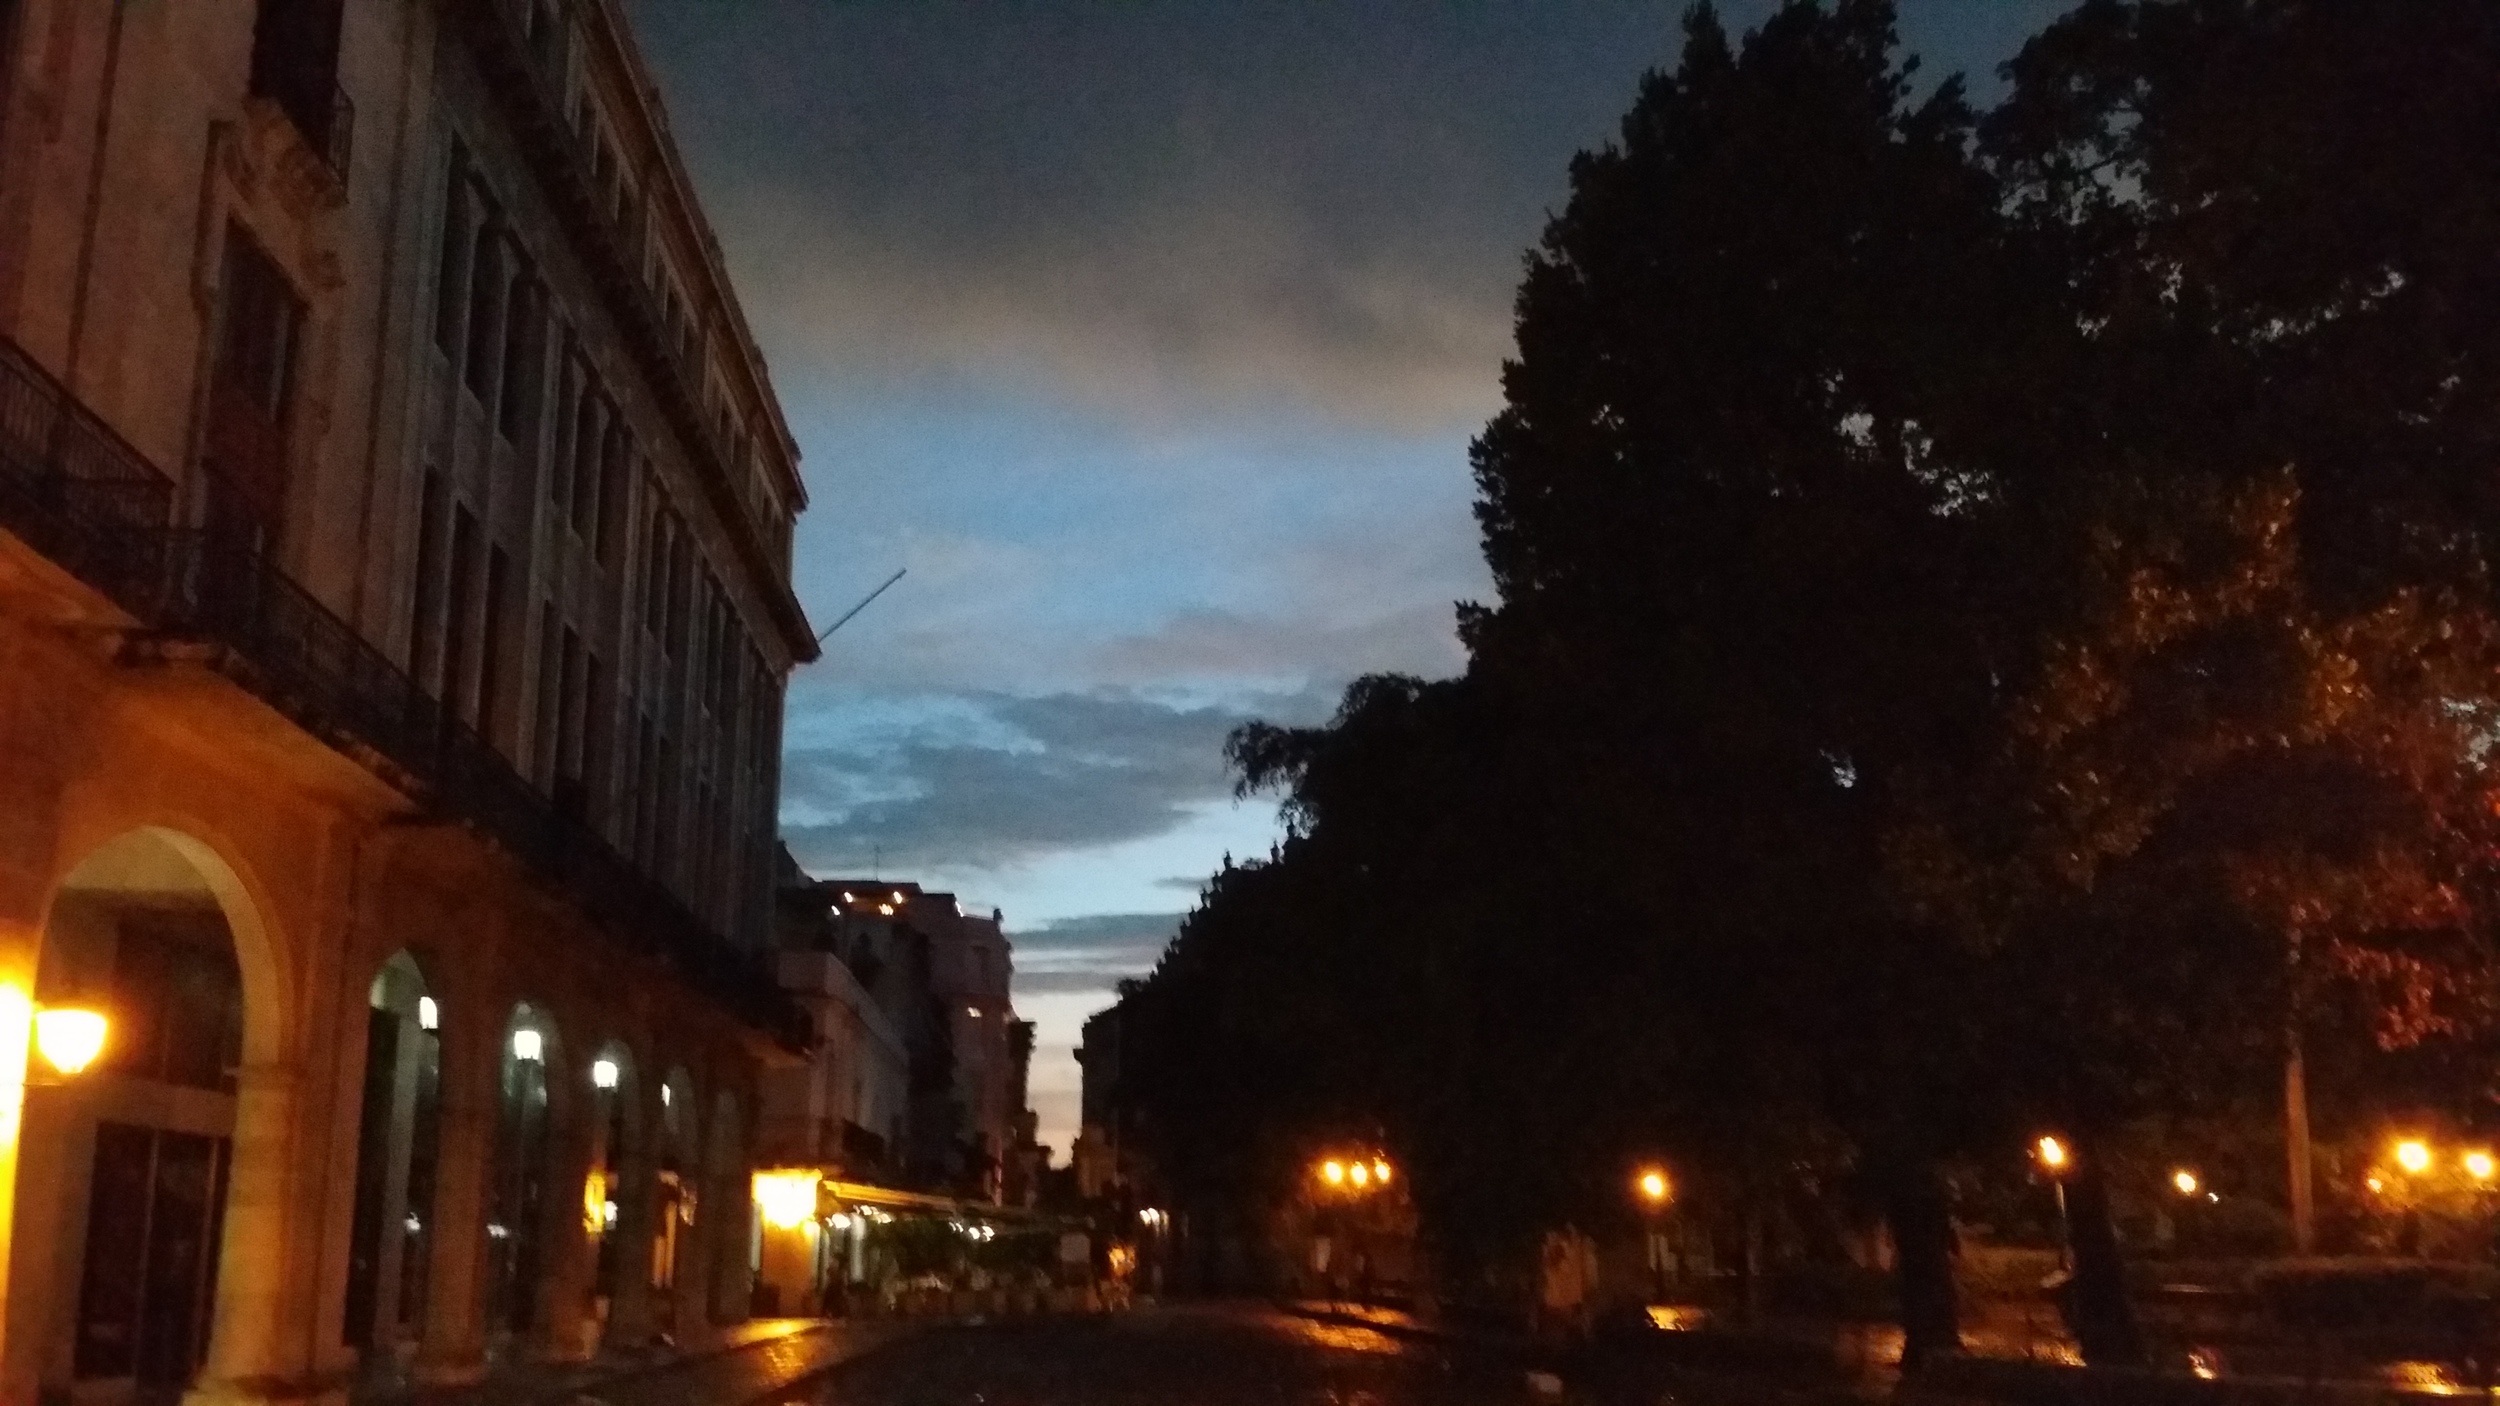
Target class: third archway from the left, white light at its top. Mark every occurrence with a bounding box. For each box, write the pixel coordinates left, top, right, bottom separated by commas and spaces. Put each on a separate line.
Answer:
485, 1001, 563, 1343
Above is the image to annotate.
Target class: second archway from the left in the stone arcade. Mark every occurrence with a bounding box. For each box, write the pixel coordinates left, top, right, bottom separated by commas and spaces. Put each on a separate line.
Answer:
343, 951, 443, 1363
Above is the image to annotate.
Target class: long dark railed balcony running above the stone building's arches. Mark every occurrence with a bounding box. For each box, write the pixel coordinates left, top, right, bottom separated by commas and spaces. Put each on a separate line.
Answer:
0, 340, 813, 1051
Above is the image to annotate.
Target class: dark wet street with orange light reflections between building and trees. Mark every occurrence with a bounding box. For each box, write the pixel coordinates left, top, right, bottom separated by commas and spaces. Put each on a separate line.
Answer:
775, 1306, 1663, 1406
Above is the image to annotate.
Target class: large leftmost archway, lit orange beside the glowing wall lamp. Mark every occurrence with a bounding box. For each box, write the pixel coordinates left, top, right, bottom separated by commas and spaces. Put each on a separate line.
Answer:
10, 828, 275, 1398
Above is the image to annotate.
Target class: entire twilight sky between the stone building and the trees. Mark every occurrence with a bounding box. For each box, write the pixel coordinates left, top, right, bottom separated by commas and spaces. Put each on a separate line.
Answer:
628, 0, 2065, 1156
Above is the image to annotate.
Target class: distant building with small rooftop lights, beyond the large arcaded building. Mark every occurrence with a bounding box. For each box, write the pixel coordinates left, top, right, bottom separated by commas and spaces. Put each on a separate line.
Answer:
765, 866, 1033, 1201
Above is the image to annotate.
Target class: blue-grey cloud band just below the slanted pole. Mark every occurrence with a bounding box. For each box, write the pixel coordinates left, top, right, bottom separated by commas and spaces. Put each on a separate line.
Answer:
783, 693, 1328, 871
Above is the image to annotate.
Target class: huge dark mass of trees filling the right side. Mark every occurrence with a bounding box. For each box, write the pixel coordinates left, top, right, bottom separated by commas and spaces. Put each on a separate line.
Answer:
1123, 0, 2500, 1358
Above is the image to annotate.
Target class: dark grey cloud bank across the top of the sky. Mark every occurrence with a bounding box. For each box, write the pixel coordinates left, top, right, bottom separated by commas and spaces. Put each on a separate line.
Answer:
633, 0, 2063, 428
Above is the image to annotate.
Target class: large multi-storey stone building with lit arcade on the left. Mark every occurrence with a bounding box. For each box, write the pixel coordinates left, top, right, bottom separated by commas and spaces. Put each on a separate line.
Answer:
0, 0, 815, 1403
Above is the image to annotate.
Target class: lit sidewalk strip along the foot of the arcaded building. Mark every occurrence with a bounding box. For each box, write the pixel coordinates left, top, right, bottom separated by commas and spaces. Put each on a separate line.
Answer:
355, 1318, 920, 1406
